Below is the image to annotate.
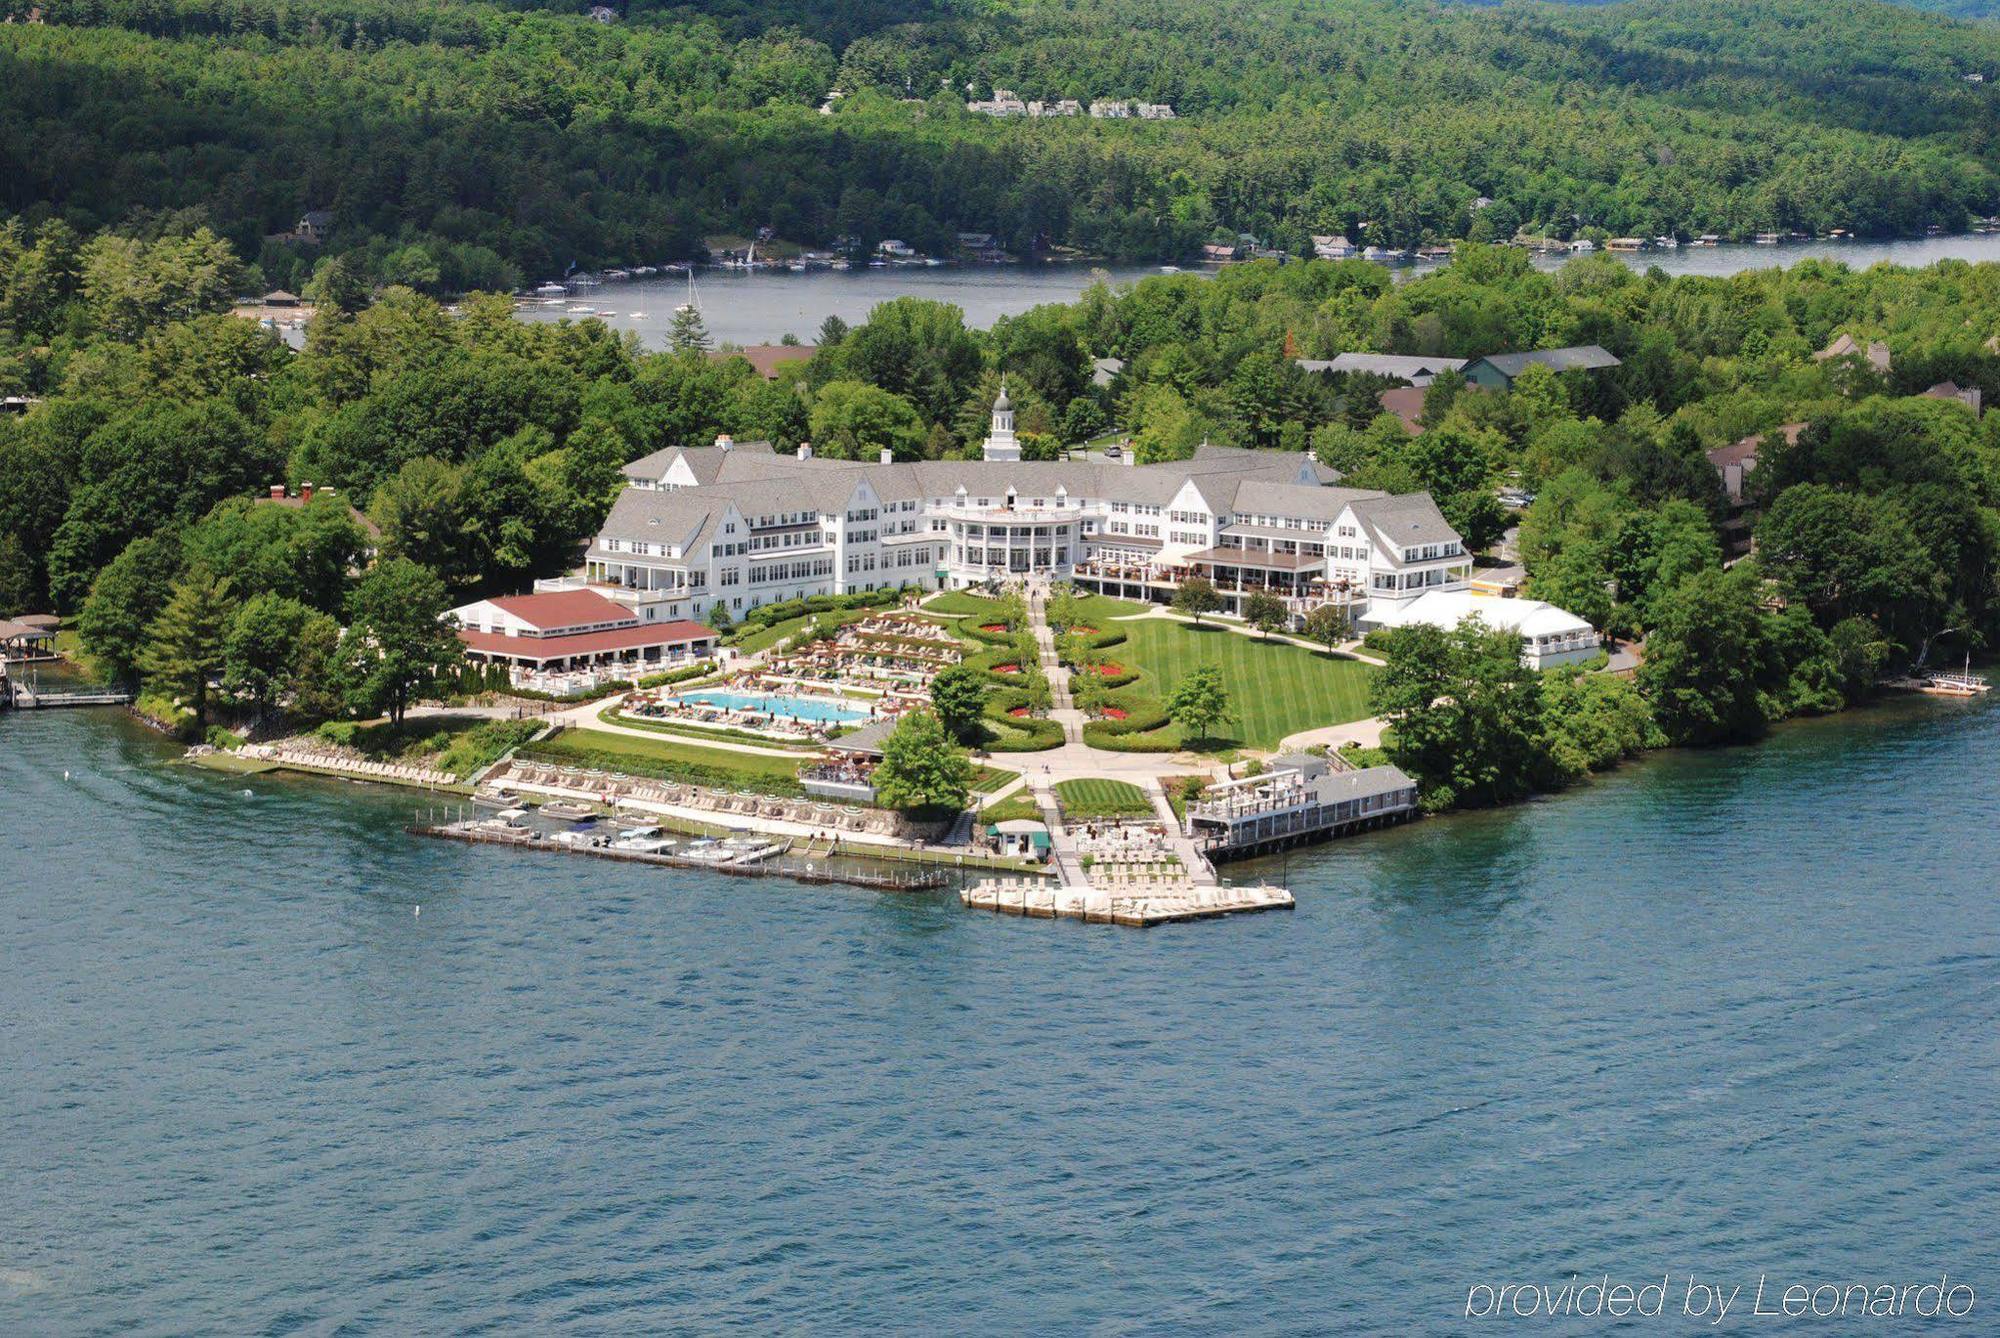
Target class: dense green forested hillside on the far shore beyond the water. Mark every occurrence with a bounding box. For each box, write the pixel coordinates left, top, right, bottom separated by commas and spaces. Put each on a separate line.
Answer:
0, 0, 2000, 294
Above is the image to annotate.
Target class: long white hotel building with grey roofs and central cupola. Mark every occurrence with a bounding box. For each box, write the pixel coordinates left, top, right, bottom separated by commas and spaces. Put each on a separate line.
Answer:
542, 390, 1472, 622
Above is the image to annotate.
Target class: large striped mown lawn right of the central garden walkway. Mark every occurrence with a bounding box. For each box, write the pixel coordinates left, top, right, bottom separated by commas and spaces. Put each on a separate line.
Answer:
1104, 618, 1374, 748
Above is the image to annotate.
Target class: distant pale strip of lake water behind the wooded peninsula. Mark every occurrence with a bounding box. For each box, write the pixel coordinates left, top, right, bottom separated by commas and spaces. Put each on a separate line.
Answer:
522, 234, 2000, 348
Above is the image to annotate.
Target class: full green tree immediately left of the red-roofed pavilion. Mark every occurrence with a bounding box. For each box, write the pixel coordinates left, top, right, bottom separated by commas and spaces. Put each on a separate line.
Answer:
344, 558, 464, 724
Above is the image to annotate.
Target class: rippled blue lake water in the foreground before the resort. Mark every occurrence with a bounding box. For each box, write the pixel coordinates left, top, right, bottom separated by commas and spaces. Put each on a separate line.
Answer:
0, 700, 2000, 1334
